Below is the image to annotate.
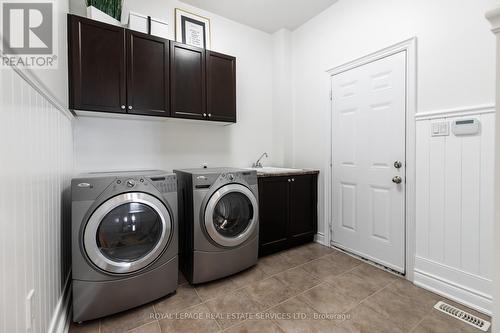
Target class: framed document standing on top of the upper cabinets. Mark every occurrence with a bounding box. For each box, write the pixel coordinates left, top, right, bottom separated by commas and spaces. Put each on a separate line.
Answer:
175, 8, 211, 49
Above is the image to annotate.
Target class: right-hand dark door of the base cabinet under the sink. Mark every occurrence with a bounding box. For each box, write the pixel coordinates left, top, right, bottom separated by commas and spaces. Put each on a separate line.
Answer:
288, 175, 318, 245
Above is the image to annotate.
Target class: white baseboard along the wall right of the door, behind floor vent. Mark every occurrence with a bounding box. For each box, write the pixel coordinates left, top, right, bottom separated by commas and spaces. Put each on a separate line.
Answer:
413, 268, 493, 316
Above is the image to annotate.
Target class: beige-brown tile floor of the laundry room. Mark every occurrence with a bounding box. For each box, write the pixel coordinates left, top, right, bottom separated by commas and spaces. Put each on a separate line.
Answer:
70, 244, 490, 333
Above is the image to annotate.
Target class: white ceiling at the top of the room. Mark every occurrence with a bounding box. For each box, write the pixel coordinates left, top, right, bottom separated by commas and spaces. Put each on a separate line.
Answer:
181, 0, 337, 33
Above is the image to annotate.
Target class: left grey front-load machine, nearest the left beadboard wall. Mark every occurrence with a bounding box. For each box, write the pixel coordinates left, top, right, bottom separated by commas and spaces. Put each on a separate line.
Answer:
71, 171, 178, 322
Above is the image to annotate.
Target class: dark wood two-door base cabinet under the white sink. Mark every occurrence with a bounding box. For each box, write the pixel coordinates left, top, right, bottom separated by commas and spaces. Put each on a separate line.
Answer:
259, 174, 318, 256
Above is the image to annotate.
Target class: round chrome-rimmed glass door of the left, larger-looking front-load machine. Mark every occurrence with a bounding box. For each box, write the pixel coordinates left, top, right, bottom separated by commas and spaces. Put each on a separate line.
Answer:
83, 192, 172, 274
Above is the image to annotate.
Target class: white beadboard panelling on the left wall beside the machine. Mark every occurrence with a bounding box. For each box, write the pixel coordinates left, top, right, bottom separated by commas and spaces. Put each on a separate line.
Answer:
0, 68, 73, 332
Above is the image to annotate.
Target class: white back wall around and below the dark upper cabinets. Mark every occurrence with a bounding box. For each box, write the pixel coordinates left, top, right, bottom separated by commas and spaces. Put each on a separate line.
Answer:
72, 0, 283, 172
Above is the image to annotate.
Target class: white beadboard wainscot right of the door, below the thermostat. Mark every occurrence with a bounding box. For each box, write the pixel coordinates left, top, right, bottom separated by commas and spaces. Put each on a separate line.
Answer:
415, 107, 495, 313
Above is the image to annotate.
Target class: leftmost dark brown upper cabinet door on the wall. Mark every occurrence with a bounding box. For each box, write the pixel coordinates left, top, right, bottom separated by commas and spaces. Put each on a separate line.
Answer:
68, 15, 126, 113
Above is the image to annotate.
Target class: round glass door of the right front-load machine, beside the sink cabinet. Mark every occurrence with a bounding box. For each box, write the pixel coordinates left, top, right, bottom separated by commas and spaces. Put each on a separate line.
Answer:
205, 184, 259, 247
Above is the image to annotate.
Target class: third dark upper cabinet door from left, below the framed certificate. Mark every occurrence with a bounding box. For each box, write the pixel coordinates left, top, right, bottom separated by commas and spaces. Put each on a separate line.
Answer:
170, 42, 206, 119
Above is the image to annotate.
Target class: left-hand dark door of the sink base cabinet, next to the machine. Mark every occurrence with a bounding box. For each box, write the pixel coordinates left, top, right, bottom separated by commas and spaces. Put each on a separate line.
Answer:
259, 177, 290, 256
